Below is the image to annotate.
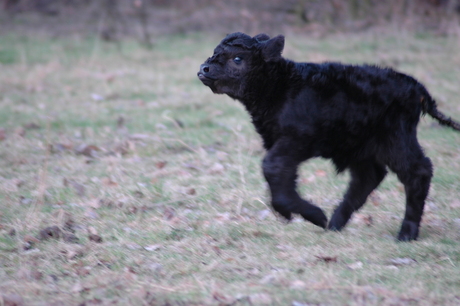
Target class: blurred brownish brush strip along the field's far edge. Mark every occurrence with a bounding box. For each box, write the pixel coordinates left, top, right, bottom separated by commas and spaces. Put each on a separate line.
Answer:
0, 0, 460, 41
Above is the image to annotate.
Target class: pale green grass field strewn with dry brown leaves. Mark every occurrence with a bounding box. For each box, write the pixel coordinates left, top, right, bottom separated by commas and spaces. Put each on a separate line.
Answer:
0, 29, 460, 306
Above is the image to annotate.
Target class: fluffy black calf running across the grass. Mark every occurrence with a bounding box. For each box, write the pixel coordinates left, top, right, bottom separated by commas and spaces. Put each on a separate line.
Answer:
198, 33, 460, 241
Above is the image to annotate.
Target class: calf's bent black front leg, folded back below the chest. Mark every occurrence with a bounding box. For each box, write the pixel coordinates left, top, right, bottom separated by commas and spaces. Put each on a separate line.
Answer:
262, 141, 327, 228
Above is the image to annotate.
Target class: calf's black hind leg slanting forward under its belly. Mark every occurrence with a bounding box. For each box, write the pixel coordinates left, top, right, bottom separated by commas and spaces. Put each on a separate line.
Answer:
328, 160, 387, 231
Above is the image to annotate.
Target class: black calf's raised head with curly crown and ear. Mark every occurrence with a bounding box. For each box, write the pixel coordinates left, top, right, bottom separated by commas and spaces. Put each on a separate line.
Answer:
198, 32, 284, 99
